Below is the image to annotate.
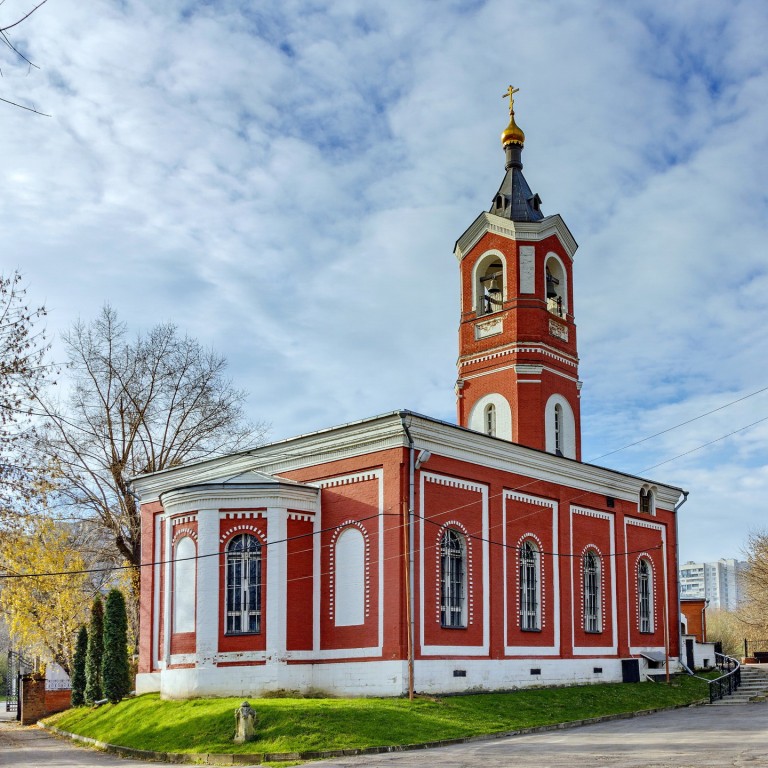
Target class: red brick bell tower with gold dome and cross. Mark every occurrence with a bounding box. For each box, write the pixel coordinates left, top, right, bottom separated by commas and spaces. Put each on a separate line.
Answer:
454, 90, 581, 460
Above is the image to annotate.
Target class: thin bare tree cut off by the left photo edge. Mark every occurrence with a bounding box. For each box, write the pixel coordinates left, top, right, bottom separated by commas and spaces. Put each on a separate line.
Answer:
0, 272, 47, 524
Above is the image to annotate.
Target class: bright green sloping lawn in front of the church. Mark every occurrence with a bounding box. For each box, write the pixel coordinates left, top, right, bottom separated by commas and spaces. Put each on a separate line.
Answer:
47, 677, 707, 753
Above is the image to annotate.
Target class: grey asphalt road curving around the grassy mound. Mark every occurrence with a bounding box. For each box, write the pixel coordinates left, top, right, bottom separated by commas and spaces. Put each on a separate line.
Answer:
0, 703, 768, 768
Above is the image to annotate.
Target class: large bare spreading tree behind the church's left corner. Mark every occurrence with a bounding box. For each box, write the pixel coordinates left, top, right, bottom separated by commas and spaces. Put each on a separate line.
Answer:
33, 306, 265, 616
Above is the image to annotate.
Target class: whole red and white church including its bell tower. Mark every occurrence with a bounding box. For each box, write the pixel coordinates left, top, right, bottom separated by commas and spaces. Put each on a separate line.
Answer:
133, 86, 686, 698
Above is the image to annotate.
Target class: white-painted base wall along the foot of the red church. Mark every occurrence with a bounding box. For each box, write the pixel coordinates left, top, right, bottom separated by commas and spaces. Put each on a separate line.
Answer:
136, 658, 646, 699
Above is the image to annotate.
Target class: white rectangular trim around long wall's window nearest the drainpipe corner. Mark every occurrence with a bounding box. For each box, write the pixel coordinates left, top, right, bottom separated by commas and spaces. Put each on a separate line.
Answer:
417, 471, 490, 656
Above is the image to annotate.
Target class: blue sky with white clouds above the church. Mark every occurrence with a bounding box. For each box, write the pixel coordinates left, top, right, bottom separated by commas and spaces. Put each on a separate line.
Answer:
0, 0, 768, 562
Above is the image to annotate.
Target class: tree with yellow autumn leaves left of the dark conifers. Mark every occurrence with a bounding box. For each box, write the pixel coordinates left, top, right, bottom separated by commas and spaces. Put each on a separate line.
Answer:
0, 517, 95, 674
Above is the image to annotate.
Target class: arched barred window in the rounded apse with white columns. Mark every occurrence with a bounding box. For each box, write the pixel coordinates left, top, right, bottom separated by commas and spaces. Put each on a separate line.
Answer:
226, 533, 261, 635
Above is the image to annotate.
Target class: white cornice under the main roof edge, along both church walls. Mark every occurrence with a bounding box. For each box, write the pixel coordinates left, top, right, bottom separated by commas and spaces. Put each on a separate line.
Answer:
134, 411, 681, 510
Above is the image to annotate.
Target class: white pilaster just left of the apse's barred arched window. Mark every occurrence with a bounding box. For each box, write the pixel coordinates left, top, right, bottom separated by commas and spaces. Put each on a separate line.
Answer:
195, 509, 221, 667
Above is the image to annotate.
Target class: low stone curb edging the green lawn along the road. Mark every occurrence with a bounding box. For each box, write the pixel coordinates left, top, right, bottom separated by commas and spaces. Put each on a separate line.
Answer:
37, 700, 708, 765
